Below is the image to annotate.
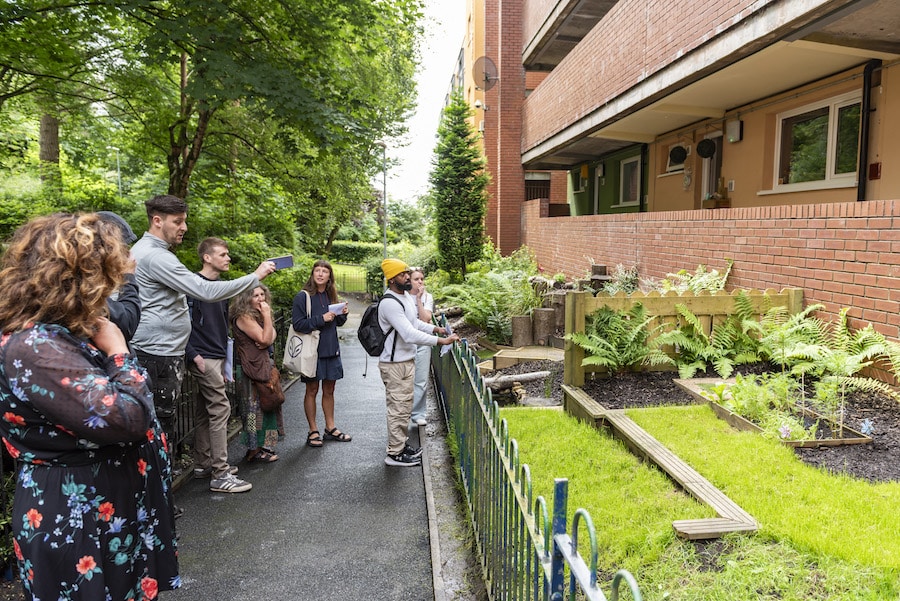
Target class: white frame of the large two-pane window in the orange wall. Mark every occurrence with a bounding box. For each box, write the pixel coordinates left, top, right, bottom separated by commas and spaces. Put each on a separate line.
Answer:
772, 91, 862, 192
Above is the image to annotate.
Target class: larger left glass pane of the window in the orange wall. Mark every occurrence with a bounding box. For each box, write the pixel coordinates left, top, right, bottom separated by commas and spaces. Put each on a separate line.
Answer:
778, 107, 828, 184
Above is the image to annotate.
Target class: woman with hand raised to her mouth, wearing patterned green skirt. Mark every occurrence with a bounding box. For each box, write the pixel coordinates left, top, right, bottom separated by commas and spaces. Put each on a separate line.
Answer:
228, 284, 284, 463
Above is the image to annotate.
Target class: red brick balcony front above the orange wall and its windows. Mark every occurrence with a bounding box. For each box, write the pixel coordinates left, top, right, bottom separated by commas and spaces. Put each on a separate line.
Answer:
522, 0, 847, 150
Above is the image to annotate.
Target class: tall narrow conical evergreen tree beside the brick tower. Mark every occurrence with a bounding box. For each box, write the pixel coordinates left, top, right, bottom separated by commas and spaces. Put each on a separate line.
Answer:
429, 91, 489, 277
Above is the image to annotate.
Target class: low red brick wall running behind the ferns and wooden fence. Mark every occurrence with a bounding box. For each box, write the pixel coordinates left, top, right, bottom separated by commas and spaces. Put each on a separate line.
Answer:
522, 200, 900, 340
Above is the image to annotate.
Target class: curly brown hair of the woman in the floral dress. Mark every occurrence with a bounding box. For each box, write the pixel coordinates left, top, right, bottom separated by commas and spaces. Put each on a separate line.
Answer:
0, 213, 128, 338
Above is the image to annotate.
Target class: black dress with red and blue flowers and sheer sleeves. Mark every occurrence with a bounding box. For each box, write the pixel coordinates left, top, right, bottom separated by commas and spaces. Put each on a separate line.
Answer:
0, 324, 181, 601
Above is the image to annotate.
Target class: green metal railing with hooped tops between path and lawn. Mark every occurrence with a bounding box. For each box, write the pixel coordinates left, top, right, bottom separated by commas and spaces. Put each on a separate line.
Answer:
432, 328, 642, 601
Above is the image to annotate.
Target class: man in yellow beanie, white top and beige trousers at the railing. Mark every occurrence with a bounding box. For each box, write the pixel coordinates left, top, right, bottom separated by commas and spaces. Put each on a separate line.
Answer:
378, 259, 459, 467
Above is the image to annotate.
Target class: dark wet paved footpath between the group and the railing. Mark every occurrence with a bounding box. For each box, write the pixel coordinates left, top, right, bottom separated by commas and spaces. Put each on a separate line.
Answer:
171, 301, 435, 601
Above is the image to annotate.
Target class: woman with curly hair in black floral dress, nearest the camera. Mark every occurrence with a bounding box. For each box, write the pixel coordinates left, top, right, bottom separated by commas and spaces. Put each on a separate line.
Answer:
0, 213, 181, 601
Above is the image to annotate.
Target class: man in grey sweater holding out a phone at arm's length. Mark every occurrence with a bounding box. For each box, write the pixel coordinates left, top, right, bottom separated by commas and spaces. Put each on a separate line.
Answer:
131, 195, 275, 482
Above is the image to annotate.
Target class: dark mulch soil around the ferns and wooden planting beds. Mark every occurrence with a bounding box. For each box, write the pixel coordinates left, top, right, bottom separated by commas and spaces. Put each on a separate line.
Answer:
496, 361, 900, 482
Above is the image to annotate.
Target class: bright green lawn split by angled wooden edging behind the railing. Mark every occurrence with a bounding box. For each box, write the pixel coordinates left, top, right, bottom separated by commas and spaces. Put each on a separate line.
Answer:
502, 406, 900, 601
